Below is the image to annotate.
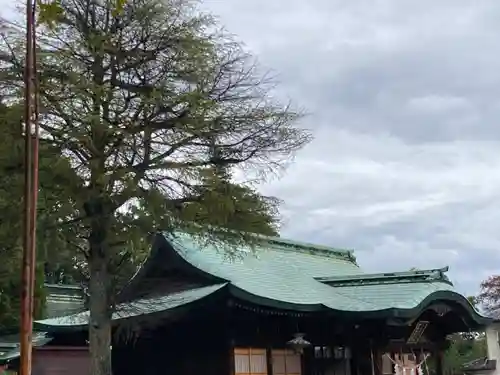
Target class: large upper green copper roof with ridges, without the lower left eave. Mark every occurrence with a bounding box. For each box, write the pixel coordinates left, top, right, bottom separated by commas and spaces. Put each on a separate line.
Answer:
168, 235, 486, 322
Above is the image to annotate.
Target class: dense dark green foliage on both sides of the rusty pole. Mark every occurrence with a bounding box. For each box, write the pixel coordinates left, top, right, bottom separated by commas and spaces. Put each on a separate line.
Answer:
0, 103, 76, 328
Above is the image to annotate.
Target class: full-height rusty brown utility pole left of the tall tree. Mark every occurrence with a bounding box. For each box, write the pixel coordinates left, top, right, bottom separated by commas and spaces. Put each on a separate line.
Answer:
20, 0, 39, 375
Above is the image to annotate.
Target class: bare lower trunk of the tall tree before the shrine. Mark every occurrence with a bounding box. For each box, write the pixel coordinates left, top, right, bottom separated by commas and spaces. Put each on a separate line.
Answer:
89, 218, 112, 375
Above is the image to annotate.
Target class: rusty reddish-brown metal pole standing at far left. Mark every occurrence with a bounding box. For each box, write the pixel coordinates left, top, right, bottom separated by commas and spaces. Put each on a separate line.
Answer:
20, 0, 36, 375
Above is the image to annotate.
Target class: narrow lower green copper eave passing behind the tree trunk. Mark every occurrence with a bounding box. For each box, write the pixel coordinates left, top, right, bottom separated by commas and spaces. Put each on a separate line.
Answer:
34, 284, 225, 331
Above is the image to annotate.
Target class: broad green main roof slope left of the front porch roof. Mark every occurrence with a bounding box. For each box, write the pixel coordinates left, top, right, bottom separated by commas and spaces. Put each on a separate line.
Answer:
170, 235, 371, 310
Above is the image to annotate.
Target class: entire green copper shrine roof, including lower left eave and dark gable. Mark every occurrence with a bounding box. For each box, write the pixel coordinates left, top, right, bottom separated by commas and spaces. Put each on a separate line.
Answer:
37, 234, 486, 328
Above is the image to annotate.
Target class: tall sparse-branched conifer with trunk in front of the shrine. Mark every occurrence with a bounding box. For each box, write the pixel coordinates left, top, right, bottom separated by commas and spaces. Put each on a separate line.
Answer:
2, 0, 310, 375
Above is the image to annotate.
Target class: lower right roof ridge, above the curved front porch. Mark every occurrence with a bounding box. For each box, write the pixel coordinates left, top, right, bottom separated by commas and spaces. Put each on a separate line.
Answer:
316, 266, 453, 287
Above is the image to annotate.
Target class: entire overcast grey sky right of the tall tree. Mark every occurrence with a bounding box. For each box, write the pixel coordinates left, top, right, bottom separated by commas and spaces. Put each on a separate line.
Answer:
199, 0, 500, 300
